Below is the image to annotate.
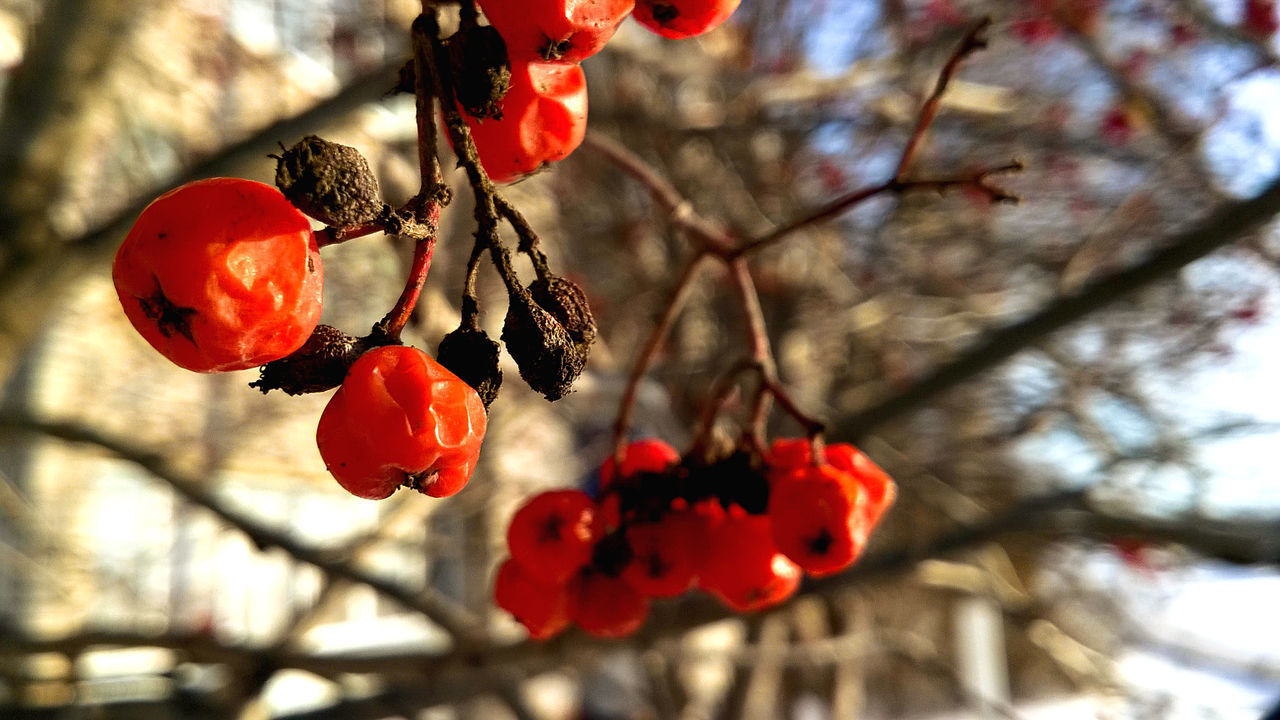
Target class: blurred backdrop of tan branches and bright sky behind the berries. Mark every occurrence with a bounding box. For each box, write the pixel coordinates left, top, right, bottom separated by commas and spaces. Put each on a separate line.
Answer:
0, 0, 1280, 720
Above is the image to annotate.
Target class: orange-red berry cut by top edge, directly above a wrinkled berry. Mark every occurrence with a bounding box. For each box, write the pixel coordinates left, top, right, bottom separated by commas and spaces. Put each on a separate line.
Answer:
480, 0, 635, 65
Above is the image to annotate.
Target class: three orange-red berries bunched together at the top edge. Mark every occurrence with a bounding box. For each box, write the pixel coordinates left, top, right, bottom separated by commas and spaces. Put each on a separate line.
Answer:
463, 0, 740, 182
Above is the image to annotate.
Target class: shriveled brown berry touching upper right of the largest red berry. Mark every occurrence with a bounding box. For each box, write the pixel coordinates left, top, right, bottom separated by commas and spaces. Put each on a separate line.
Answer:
275, 135, 384, 227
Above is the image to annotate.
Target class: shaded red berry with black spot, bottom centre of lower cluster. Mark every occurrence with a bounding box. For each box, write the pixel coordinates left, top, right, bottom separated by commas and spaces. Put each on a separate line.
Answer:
622, 511, 705, 597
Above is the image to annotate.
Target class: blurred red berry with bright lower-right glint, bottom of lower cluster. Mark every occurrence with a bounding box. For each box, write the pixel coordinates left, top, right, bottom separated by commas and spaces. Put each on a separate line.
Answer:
699, 507, 800, 612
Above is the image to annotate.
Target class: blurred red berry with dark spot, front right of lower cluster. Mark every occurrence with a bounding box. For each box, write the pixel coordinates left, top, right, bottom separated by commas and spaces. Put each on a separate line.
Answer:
769, 465, 870, 577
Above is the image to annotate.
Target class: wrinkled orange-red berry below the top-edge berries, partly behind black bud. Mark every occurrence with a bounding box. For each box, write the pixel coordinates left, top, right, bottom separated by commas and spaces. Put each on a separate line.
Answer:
465, 63, 586, 182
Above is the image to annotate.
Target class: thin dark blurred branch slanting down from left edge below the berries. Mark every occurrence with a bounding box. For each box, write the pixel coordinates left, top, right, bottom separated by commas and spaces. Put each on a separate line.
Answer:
0, 414, 483, 646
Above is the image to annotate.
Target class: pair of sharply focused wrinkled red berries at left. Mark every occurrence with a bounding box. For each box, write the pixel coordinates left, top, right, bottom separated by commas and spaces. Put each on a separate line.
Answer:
111, 178, 485, 498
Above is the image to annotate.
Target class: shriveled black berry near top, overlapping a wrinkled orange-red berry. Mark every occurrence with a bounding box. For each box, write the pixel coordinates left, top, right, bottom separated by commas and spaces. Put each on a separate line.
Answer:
448, 24, 511, 119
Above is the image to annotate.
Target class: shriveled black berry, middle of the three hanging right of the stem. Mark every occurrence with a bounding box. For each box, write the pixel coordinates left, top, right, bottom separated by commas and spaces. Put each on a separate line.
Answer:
502, 288, 586, 402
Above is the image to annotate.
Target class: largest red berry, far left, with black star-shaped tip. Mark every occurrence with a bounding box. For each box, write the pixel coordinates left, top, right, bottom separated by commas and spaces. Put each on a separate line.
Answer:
111, 178, 324, 373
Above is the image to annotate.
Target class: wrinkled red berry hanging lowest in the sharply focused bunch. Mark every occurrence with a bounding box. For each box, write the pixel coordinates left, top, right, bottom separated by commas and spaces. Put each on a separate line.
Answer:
316, 345, 486, 500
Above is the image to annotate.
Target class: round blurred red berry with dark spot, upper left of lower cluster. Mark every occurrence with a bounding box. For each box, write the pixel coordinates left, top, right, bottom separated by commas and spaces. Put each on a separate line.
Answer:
507, 489, 600, 583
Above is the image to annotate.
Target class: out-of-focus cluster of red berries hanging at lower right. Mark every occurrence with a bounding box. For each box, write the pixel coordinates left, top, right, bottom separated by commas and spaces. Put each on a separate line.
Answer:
494, 438, 896, 639
